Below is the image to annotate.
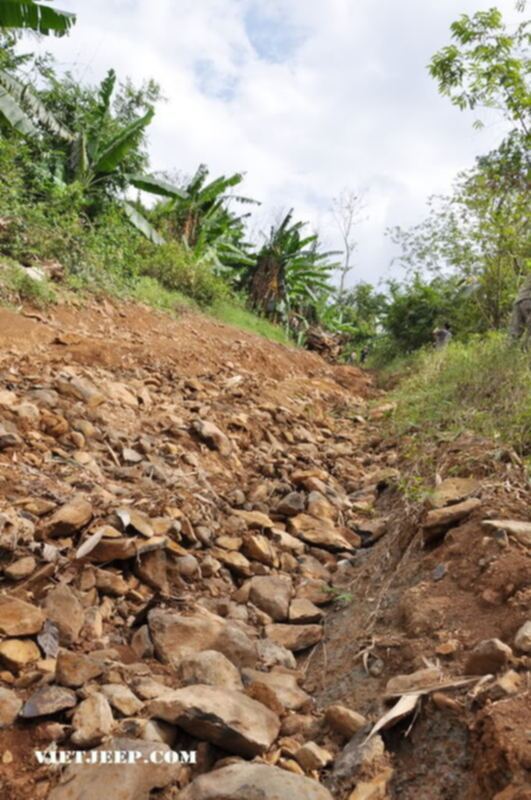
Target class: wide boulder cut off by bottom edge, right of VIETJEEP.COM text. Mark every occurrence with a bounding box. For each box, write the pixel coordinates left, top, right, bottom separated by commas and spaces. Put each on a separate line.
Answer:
177, 764, 332, 800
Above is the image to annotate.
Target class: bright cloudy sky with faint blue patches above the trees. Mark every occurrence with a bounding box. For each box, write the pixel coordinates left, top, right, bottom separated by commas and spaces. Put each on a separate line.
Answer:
31, 0, 517, 283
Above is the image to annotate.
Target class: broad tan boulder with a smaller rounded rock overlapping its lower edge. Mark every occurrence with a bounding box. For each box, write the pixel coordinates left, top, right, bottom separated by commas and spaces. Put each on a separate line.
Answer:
148, 609, 257, 668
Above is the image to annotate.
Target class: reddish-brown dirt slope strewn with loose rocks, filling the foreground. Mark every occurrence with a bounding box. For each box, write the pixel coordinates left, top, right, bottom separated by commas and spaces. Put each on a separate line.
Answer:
0, 301, 531, 800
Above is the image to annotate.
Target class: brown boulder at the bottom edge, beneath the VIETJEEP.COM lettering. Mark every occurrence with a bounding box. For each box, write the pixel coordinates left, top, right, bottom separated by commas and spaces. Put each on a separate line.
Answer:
48, 738, 183, 800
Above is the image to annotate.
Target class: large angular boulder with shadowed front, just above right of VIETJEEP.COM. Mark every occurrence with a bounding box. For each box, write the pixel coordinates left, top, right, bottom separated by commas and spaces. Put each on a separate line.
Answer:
148, 684, 280, 758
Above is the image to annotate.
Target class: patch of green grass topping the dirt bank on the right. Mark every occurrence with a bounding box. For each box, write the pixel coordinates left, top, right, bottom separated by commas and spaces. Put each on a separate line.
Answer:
391, 334, 531, 456
